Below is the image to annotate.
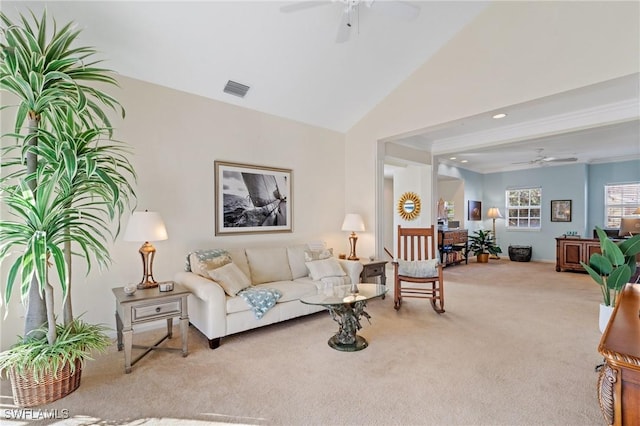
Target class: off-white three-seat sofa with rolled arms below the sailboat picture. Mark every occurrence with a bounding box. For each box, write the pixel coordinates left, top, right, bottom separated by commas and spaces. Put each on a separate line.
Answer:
174, 245, 362, 349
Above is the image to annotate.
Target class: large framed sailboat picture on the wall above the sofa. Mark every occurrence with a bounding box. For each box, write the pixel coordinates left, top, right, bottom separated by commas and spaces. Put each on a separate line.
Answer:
214, 161, 293, 236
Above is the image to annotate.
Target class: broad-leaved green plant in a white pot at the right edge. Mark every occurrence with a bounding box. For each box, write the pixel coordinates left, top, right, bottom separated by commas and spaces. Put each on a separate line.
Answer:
580, 227, 640, 333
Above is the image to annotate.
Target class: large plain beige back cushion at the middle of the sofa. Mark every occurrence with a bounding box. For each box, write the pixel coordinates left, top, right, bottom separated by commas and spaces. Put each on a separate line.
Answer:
245, 247, 293, 284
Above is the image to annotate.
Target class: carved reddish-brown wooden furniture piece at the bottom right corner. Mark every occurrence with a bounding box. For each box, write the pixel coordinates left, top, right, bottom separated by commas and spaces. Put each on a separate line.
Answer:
598, 284, 640, 426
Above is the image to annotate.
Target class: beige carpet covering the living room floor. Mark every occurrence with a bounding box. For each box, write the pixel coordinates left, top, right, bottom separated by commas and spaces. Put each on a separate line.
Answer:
1, 259, 604, 426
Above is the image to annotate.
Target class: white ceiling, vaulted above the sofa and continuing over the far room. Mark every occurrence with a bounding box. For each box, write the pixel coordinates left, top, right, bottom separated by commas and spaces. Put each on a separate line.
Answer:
0, 0, 640, 173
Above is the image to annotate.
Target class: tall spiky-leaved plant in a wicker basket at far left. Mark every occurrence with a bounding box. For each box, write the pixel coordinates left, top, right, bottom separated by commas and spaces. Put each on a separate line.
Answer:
0, 12, 135, 407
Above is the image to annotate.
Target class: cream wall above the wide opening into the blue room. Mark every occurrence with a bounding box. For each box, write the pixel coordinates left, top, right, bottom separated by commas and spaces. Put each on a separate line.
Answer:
345, 2, 640, 251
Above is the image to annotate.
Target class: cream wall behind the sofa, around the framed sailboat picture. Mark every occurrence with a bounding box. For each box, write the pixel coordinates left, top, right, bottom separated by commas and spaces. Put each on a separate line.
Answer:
0, 77, 350, 348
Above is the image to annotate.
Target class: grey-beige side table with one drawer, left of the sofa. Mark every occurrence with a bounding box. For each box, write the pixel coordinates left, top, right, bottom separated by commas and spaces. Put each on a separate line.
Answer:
112, 283, 191, 373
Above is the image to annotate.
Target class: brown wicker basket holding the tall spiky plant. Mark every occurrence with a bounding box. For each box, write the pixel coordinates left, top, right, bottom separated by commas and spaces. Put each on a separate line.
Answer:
8, 358, 82, 407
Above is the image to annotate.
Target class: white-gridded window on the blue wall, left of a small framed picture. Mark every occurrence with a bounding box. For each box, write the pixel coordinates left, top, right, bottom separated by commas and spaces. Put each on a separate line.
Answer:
505, 188, 542, 229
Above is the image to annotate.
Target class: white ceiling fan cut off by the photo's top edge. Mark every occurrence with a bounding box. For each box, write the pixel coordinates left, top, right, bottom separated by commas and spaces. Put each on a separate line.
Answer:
280, 0, 420, 43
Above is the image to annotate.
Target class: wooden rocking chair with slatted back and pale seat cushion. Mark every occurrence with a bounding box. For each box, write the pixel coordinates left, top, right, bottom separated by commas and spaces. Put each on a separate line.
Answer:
392, 225, 444, 314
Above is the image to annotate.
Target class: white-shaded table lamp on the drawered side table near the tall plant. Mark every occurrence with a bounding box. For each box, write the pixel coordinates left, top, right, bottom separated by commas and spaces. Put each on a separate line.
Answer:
123, 210, 168, 289
